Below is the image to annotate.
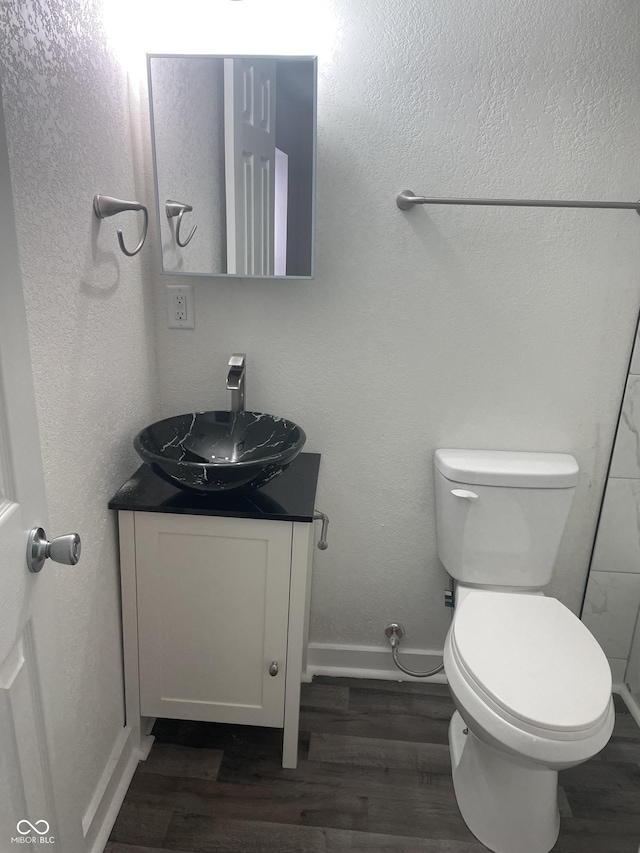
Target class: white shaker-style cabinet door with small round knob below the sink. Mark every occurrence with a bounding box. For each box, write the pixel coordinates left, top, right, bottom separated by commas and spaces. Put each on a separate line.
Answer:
135, 513, 292, 727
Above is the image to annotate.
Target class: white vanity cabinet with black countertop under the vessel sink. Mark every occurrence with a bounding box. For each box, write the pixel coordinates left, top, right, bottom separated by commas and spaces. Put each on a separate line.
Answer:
110, 454, 319, 767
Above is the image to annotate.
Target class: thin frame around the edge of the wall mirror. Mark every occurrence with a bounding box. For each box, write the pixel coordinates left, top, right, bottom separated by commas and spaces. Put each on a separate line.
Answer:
147, 53, 318, 281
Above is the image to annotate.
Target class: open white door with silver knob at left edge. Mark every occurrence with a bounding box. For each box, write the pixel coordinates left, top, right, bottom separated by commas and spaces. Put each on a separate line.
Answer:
0, 88, 72, 853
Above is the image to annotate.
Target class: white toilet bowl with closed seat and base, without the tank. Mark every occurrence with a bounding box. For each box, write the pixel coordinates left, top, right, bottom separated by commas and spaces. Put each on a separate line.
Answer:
444, 591, 614, 853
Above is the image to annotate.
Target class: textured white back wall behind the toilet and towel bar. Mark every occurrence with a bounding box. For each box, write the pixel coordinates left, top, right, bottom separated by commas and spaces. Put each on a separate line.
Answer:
145, 0, 640, 648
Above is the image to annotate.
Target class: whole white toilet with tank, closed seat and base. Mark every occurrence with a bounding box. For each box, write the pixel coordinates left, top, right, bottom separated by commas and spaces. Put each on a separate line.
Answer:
434, 450, 614, 853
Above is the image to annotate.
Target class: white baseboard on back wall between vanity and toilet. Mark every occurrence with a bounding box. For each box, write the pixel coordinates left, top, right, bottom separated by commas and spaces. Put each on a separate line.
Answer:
303, 643, 447, 684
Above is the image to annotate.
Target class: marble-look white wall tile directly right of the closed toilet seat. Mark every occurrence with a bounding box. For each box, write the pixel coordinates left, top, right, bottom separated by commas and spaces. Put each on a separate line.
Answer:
582, 571, 640, 659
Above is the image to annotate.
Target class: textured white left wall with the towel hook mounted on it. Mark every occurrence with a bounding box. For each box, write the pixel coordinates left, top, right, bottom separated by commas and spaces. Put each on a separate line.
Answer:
0, 0, 155, 840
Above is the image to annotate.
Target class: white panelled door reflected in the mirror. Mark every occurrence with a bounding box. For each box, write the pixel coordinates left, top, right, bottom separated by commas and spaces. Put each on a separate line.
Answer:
224, 57, 276, 275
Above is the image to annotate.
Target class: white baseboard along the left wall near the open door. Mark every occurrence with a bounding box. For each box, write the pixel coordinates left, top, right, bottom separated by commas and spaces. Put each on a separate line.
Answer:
82, 726, 153, 853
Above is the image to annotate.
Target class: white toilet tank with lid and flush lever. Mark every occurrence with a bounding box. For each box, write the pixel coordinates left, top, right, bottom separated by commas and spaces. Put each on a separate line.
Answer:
434, 450, 579, 587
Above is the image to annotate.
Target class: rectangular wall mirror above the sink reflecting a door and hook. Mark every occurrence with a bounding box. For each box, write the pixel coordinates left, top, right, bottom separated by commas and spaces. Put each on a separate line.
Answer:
147, 54, 317, 278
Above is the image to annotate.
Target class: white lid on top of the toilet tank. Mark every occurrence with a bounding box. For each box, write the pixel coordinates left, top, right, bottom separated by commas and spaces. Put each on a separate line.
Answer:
434, 449, 580, 489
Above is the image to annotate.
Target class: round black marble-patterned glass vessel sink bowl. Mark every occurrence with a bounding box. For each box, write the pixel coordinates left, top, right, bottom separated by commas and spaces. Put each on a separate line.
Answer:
133, 412, 307, 492
